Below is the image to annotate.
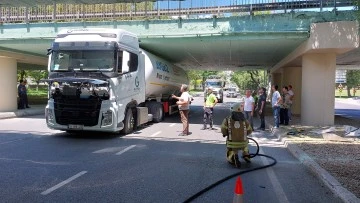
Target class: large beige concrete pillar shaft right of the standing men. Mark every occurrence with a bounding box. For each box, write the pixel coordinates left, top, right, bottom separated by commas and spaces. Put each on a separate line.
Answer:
301, 53, 336, 126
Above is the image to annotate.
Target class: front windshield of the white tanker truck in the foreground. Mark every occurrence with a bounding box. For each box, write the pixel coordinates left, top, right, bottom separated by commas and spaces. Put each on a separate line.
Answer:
50, 50, 116, 72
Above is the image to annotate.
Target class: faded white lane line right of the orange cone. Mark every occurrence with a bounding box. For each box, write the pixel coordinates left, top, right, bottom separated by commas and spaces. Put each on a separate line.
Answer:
259, 148, 289, 203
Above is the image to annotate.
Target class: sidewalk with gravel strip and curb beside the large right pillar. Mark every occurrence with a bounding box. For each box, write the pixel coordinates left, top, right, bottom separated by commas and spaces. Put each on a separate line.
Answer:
266, 114, 360, 203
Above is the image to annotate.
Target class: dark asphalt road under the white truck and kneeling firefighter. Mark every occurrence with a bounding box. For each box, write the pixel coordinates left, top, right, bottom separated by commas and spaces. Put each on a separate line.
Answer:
0, 97, 341, 203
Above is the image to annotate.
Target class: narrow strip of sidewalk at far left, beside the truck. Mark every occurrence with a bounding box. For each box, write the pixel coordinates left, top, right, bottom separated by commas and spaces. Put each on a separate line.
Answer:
0, 105, 45, 119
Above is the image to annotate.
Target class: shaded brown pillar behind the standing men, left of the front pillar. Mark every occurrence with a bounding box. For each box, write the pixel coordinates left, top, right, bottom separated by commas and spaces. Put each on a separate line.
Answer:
282, 67, 302, 115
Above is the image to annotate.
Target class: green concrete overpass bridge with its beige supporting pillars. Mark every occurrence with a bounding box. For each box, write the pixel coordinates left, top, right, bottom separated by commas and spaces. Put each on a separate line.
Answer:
0, 0, 360, 125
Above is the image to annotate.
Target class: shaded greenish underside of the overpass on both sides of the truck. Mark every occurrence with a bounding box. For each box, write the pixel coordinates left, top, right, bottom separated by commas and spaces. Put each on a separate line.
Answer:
0, 32, 360, 71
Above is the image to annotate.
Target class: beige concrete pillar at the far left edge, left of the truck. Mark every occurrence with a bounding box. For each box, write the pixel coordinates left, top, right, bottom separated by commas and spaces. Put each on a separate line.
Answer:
0, 56, 17, 112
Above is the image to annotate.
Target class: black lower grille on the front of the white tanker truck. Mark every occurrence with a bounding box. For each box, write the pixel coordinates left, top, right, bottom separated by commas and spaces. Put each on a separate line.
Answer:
54, 98, 101, 126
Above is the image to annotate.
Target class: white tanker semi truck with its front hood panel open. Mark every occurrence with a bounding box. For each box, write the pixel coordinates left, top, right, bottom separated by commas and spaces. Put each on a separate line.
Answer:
46, 29, 188, 134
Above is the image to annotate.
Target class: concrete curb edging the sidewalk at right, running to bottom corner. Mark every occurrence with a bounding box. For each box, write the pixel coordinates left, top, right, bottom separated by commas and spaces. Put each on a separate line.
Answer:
269, 125, 360, 203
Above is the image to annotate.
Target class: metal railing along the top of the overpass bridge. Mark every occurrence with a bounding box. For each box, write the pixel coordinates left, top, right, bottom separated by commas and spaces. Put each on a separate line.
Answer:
0, 0, 354, 23
